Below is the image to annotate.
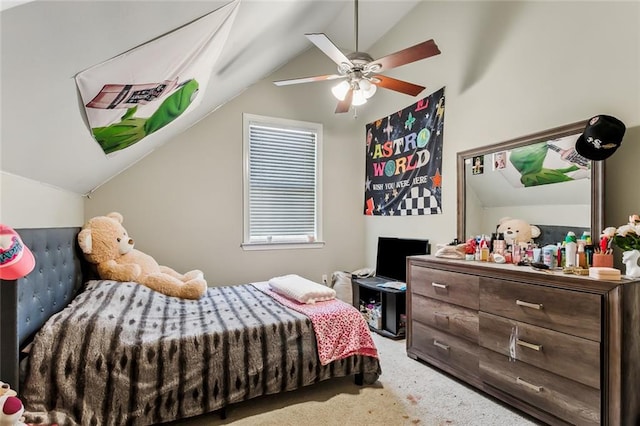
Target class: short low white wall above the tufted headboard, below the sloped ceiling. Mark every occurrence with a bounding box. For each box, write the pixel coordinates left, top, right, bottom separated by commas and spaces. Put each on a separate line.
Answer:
0, 172, 84, 228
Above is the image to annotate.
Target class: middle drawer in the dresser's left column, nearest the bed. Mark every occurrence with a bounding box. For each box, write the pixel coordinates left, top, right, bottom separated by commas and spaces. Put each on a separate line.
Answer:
411, 294, 478, 343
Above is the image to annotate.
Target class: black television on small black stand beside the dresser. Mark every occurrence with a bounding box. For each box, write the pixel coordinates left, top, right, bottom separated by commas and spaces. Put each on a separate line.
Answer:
376, 237, 431, 282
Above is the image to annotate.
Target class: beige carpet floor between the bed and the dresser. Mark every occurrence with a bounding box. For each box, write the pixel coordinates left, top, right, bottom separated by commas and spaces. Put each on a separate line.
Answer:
173, 334, 537, 426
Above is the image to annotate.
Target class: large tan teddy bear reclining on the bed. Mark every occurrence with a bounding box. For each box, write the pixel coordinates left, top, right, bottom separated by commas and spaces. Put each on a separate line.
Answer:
78, 212, 207, 299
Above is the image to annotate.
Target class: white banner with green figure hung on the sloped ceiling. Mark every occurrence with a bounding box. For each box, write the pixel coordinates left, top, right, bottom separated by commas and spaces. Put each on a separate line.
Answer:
75, 0, 240, 154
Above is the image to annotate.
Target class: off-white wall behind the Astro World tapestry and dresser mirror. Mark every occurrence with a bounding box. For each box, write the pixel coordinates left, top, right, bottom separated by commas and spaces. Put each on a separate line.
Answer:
360, 1, 640, 264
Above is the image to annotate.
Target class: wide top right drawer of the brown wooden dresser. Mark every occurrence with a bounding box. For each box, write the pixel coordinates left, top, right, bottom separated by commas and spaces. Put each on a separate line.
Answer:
480, 278, 602, 342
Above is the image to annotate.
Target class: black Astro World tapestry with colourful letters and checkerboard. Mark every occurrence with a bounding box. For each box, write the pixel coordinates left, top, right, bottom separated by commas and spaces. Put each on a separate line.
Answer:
364, 87, 444, 216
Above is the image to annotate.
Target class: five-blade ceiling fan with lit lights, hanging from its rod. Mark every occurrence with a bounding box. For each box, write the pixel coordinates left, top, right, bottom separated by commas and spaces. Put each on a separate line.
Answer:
273, 0, 440, 113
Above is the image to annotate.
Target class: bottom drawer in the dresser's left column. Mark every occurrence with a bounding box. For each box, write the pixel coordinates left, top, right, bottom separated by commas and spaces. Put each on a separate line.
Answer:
412, 321, 478, 377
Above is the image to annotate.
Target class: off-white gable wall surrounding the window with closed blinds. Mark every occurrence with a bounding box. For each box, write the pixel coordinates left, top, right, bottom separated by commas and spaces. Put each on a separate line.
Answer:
86, 50, 364, 285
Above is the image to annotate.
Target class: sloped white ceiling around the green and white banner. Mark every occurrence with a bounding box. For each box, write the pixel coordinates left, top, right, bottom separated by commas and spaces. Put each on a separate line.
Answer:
0, 0, 420, 194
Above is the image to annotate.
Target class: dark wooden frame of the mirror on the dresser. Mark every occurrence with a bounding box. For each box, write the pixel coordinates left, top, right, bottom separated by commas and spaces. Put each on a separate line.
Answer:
457, 120, 604, 242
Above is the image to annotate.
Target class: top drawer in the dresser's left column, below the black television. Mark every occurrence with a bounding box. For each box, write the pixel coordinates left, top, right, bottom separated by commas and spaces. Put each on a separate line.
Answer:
409, 266, 479, 309
